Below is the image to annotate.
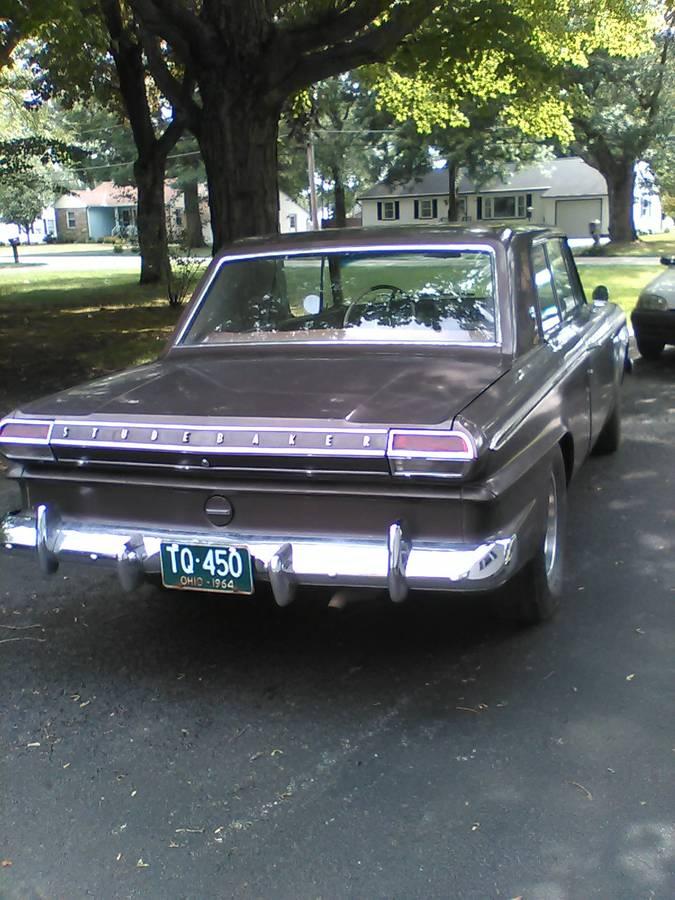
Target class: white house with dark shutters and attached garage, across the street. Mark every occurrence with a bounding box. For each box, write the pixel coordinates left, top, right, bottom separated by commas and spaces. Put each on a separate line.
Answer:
359, 157, 661, 238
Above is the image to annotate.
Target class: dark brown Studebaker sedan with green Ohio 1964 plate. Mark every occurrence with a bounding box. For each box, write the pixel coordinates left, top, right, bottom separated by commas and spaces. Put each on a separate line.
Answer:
0, 226, 628, 623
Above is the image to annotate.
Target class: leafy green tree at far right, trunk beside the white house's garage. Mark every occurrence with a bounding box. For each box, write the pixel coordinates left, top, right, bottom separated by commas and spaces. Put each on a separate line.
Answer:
571, 29, 675, 241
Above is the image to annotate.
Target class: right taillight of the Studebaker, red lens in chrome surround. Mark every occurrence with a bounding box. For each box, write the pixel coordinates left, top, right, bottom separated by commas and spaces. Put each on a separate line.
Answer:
387, 429, 477, 478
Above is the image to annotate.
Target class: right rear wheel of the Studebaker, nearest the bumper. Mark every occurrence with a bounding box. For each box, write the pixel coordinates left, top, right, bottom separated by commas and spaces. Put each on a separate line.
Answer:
507, 449, 567, 626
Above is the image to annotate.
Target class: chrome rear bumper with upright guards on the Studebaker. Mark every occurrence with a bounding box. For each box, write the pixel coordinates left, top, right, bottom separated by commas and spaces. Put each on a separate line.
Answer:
0, 506, 517, 606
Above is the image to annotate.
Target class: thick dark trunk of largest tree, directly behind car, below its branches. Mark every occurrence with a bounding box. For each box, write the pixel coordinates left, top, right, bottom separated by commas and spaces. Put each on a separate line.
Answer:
196, 84, 281, 254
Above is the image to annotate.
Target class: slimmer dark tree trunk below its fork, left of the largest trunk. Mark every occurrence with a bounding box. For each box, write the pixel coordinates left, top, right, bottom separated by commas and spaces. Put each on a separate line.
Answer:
134, 153, 170, 284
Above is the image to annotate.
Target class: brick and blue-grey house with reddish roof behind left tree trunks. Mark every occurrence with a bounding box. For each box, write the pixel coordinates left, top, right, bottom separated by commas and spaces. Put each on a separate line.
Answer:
54, 181, 311, 244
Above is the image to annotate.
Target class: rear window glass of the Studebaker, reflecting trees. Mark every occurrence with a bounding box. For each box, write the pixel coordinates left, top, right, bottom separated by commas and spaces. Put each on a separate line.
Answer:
183, 249, 497, 345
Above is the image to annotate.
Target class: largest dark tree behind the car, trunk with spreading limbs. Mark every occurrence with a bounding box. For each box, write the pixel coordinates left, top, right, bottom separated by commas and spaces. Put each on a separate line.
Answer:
130, 0, 436, 250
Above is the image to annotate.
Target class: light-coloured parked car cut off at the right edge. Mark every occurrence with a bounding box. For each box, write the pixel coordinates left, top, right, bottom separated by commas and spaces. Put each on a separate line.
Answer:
631, 256, 675, 359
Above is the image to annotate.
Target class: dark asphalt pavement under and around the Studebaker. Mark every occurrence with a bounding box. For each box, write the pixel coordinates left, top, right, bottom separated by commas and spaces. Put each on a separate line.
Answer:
0, 349, 675, 900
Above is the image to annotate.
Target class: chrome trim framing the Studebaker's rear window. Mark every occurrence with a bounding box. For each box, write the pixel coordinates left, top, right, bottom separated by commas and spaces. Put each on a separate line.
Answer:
171, 243, 502, 349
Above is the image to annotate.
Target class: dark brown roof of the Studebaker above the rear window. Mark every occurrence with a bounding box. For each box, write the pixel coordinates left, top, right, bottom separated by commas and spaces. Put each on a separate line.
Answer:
216, 224, 563, 259
